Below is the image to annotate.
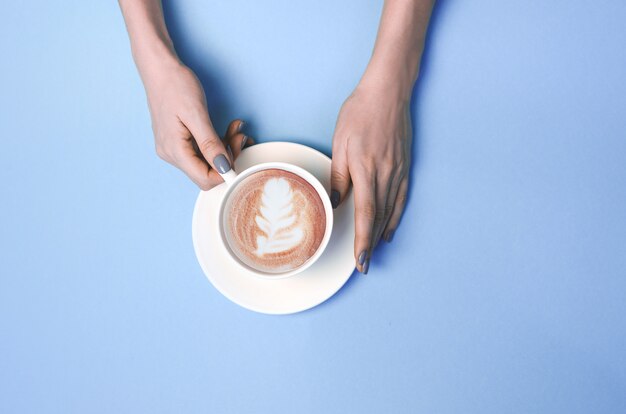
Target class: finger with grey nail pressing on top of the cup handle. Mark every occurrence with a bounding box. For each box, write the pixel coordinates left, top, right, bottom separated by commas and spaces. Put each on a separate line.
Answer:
182, 110, 232, 174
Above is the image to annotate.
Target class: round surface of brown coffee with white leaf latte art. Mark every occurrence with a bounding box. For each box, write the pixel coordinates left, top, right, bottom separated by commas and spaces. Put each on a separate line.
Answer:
223, 168, 326, 273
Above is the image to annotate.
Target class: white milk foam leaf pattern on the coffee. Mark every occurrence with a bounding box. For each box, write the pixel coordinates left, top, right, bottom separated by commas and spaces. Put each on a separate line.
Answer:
255, 178, 304, 256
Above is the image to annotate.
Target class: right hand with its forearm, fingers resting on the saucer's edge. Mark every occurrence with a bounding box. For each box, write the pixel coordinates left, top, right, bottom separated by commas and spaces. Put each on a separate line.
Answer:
324, 0, 434, 273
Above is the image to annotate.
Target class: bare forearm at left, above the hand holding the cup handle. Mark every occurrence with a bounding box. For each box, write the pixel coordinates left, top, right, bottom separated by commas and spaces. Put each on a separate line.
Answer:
119, 0, 180, 86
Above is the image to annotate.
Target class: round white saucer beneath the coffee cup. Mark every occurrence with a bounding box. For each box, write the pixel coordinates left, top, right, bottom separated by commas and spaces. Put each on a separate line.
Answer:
192, 142, 355, 314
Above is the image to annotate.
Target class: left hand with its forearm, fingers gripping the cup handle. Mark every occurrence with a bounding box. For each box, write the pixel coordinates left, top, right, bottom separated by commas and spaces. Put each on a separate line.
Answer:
119, 0, 252, 190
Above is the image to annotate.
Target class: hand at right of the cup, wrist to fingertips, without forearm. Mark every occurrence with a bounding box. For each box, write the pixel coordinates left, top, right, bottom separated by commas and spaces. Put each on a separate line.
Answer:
331, 86, 412, 274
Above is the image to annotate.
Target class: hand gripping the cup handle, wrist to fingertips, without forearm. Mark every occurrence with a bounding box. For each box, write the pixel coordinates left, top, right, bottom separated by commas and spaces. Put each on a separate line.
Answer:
144, 61, 252, 190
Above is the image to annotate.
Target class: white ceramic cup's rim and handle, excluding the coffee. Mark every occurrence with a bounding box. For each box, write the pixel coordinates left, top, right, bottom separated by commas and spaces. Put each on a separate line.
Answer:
217, 162, 333, 279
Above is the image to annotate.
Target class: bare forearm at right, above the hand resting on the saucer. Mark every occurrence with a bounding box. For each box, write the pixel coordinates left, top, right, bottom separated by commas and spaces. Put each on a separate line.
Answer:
359, 0, 434, 100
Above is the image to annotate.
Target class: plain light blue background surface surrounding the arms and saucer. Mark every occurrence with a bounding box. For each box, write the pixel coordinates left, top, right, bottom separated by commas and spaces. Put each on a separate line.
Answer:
0, 0, 626, 413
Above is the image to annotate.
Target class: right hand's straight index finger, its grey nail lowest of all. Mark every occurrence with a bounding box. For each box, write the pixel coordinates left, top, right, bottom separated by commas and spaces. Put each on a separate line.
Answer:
351, 167, 376, 274
